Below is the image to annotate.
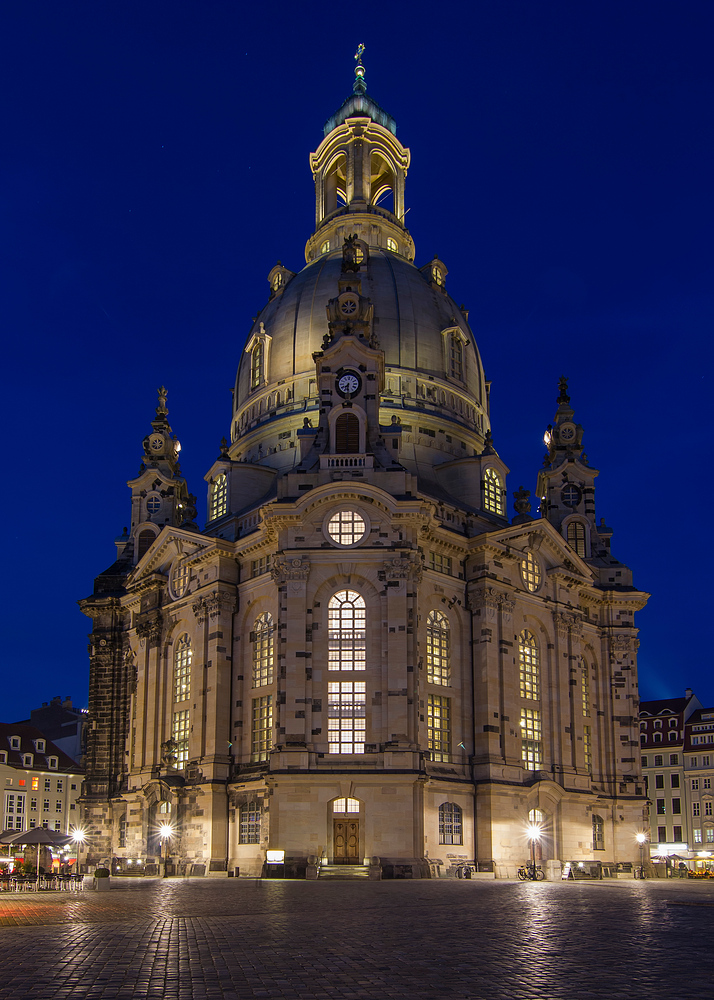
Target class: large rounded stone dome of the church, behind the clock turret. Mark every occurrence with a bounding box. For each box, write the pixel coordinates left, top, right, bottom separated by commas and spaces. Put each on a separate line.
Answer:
231, 247, 489, 484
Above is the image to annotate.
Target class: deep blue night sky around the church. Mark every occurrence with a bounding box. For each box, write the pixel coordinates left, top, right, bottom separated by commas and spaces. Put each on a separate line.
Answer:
0, 0, 714, 722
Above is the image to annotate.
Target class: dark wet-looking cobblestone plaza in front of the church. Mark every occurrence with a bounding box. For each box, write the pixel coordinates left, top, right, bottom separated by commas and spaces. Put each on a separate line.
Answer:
0, 879, 714, 1000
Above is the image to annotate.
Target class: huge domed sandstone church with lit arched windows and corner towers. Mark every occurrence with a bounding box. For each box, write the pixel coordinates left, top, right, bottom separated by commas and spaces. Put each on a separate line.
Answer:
81, 63, 648, 877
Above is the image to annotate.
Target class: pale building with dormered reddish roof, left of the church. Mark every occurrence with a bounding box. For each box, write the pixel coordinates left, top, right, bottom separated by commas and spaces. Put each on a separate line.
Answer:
0, 722, 84, 833
